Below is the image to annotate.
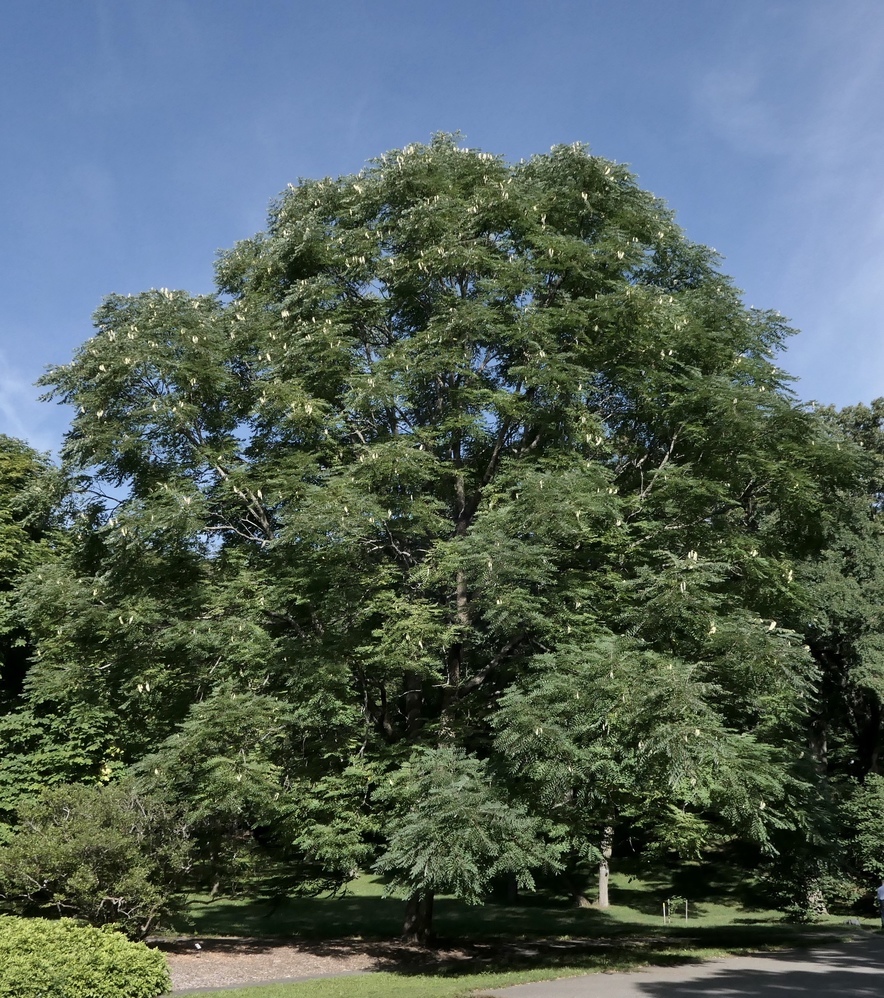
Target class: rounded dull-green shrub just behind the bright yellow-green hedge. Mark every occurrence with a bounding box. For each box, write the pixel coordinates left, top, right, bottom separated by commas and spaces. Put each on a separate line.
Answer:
0, 784, 189, 938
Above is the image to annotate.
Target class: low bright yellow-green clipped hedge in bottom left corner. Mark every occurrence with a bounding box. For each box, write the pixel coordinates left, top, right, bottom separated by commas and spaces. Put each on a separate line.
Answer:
0, 915, 172, 998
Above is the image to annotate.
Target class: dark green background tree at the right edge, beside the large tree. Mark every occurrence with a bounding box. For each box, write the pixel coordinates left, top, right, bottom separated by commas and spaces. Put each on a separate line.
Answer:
791, 399, 884, 910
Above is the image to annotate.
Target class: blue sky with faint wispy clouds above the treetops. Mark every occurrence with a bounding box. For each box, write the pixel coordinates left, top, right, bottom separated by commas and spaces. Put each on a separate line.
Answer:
0, 0, 884, 450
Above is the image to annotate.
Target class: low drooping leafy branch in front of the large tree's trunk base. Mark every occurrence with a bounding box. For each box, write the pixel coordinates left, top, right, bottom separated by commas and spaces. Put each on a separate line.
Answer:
375, 748, 558, 904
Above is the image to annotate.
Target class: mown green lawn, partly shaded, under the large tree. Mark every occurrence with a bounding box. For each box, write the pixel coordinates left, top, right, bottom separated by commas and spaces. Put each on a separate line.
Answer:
164, 868, 880, 998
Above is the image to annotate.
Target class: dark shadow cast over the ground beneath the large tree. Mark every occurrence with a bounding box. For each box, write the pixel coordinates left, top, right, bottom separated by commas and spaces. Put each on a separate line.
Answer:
160, 881, 837, 973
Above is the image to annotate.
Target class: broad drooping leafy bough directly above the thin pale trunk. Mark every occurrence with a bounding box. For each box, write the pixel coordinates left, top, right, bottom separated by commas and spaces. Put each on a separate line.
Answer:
494, 636, 800, 857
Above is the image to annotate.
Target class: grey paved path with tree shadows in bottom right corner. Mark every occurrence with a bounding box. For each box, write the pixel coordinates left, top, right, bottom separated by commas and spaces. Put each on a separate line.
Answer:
482, 937, 884, 998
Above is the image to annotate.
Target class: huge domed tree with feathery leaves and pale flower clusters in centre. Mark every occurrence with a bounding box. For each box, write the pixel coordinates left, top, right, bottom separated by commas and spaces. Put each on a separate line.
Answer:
29, 136, 855, 934
